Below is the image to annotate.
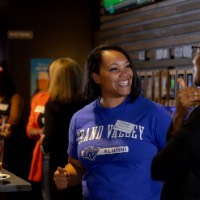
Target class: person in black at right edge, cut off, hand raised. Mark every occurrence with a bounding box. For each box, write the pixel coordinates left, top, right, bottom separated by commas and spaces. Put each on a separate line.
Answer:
151, 47, 200, 200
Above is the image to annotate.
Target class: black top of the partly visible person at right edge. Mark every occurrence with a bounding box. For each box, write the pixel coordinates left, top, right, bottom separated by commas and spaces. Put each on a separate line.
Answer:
151, 106, 200, 200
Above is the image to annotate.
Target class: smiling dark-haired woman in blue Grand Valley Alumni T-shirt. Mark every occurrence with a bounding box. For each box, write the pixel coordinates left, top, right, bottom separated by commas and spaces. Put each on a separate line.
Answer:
54, 44, 172, 200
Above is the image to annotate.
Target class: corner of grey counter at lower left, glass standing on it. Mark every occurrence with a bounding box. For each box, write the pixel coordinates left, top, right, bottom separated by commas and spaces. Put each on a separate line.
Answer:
0, 169, 31, 192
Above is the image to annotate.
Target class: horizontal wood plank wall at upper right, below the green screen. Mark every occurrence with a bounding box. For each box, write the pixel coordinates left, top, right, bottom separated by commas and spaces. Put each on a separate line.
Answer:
97, 0, 200, 70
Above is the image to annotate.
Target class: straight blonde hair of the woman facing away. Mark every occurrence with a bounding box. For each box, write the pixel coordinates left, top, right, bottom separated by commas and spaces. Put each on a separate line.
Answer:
48, 57, 83, 103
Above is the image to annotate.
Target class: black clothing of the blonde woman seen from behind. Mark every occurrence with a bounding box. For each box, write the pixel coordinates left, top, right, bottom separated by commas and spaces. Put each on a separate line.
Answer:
42, 100, 89, 199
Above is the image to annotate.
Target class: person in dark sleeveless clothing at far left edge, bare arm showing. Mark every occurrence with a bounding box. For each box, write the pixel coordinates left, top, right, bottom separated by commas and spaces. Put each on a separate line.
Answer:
0, 66, 24, 175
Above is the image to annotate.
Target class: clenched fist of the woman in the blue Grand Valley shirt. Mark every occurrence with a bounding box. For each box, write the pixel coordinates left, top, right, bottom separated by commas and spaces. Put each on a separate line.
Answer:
54, 167, 70, 190
